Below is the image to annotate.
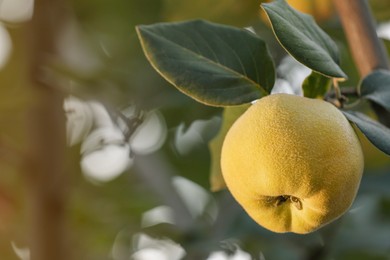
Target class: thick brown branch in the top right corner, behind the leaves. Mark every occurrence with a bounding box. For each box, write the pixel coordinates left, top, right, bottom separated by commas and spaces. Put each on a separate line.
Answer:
333, 0, 390, 127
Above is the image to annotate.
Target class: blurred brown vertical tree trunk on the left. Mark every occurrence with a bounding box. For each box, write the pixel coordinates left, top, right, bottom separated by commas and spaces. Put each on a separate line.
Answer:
25, 0, 69, 260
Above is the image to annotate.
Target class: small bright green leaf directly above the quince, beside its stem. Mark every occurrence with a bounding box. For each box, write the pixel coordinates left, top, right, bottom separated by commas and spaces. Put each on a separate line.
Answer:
302, 71, 332, 98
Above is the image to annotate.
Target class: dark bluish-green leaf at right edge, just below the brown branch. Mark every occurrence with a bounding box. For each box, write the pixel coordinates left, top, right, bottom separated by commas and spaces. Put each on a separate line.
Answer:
359, 70, 390, 112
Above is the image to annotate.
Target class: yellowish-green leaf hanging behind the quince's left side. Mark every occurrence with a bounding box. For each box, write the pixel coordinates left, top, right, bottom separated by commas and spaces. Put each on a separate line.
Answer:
209, 104, 250, 191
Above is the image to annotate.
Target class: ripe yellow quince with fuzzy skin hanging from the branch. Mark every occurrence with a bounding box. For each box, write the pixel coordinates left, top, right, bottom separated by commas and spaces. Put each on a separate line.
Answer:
221, 94, 364, 234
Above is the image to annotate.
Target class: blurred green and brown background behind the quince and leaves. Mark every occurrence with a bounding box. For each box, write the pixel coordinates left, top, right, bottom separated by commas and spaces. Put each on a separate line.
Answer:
0, 0, 390, 260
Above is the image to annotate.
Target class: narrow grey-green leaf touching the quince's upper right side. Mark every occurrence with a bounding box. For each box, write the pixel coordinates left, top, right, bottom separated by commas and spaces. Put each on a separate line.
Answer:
342, 111, 390, 155
